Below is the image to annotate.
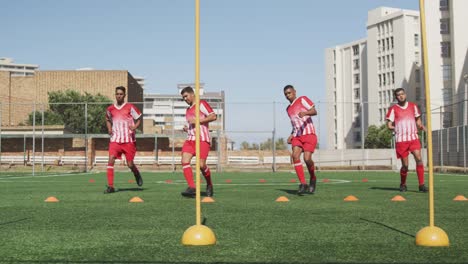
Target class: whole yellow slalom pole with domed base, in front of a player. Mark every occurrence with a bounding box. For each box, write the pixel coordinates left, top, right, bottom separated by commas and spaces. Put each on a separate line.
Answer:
182, 0, 216, 246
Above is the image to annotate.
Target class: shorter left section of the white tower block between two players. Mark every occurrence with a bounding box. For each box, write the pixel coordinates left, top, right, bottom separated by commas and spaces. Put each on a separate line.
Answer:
325, 39, 368, 149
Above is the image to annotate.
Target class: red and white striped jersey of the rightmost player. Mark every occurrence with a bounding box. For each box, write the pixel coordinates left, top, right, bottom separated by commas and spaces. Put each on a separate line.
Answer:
386, 102, 421, 142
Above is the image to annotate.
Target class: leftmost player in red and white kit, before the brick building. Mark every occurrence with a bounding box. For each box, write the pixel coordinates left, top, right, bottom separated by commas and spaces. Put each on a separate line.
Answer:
104, 86, 143, 193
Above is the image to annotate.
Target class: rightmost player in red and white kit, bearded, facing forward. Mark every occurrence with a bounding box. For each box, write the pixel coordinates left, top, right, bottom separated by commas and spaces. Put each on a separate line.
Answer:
386, 88, 427, 192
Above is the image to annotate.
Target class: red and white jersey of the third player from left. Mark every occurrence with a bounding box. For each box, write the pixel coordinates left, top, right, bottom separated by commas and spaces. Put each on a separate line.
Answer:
286, 96, 315, 137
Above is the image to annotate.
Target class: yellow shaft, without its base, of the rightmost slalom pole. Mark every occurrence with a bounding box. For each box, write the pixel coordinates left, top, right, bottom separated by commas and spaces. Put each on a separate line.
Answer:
419, 0, 434, 227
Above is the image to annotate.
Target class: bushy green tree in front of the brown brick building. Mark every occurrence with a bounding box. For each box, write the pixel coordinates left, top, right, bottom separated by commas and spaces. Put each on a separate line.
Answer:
28, 90, 112, 134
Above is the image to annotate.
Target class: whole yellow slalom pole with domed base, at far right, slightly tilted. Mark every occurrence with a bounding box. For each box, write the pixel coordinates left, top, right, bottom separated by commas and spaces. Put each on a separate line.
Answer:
416, 0, 449, 247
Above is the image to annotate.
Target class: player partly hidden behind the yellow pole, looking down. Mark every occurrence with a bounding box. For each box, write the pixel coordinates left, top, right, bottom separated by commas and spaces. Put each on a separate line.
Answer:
180, 86, 217, 197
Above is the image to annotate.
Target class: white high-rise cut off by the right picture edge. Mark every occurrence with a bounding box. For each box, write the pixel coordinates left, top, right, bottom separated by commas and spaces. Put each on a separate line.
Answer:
425, 0, 468, 130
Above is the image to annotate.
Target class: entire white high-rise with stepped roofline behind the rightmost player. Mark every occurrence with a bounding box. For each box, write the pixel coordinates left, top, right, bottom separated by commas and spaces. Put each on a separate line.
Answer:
325, 7, 423, 149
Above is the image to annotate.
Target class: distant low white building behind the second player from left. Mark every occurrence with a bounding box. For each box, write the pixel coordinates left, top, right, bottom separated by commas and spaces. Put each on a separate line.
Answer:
143, 84, 225, 134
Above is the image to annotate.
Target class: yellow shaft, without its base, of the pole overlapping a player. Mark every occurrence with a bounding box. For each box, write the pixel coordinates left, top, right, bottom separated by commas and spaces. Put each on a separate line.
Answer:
195, 0, 201, 226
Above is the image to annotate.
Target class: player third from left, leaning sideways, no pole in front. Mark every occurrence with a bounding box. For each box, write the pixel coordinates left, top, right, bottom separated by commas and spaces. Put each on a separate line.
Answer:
283, 85, 317, 195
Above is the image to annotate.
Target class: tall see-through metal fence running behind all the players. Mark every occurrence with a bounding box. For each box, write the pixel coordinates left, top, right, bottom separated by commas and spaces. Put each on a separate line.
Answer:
0, 101, 468, 175
